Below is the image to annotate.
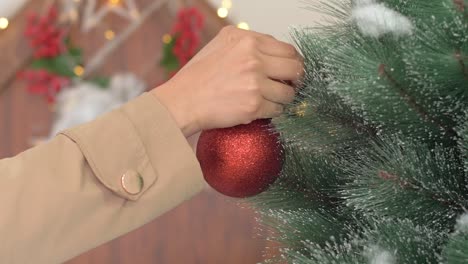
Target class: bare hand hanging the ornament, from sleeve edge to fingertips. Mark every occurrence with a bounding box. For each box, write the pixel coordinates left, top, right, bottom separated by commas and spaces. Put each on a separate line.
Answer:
152, 26, 304, 137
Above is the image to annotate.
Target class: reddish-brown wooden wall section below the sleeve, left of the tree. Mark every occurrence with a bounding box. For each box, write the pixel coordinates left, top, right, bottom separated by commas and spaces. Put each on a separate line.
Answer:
67, 191, 265, 264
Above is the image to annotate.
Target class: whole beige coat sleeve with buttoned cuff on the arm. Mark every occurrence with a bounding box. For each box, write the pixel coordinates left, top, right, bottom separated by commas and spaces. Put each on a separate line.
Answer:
0, 93, 205, 264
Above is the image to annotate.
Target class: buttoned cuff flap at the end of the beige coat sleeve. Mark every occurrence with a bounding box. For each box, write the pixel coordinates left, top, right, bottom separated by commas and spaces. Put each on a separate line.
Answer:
61, 93, 204, 201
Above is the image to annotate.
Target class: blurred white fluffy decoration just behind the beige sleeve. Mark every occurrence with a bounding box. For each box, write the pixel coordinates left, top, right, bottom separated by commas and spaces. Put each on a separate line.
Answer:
50, 74, 146, 137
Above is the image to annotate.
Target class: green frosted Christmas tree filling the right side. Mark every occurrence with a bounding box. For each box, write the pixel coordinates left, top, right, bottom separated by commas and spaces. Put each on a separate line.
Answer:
253, 0, 468, 263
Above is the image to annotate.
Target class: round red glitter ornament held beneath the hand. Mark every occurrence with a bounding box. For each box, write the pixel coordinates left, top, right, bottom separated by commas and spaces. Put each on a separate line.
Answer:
197, 119, 284, 198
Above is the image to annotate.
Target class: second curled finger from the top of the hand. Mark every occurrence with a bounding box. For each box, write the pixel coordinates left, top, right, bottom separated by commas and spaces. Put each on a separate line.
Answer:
260, 55, 304, 82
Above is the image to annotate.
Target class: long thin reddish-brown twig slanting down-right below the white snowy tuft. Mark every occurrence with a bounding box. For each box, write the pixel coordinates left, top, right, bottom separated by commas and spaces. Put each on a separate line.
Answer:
379, 63, 457, 137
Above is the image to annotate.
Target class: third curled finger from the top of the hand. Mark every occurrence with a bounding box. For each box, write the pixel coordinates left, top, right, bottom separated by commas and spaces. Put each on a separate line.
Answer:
261, 79, 296, 104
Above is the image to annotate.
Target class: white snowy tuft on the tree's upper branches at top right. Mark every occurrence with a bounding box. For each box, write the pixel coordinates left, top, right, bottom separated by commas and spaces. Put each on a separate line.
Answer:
351, 0, 413, 38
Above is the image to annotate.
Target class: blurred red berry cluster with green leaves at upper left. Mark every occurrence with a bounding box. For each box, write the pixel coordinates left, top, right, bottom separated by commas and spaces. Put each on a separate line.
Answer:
17, 6, 107, 103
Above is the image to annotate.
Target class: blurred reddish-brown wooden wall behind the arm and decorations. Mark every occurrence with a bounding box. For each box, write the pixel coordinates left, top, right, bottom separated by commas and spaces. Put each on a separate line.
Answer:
0, 0, 278, 264
